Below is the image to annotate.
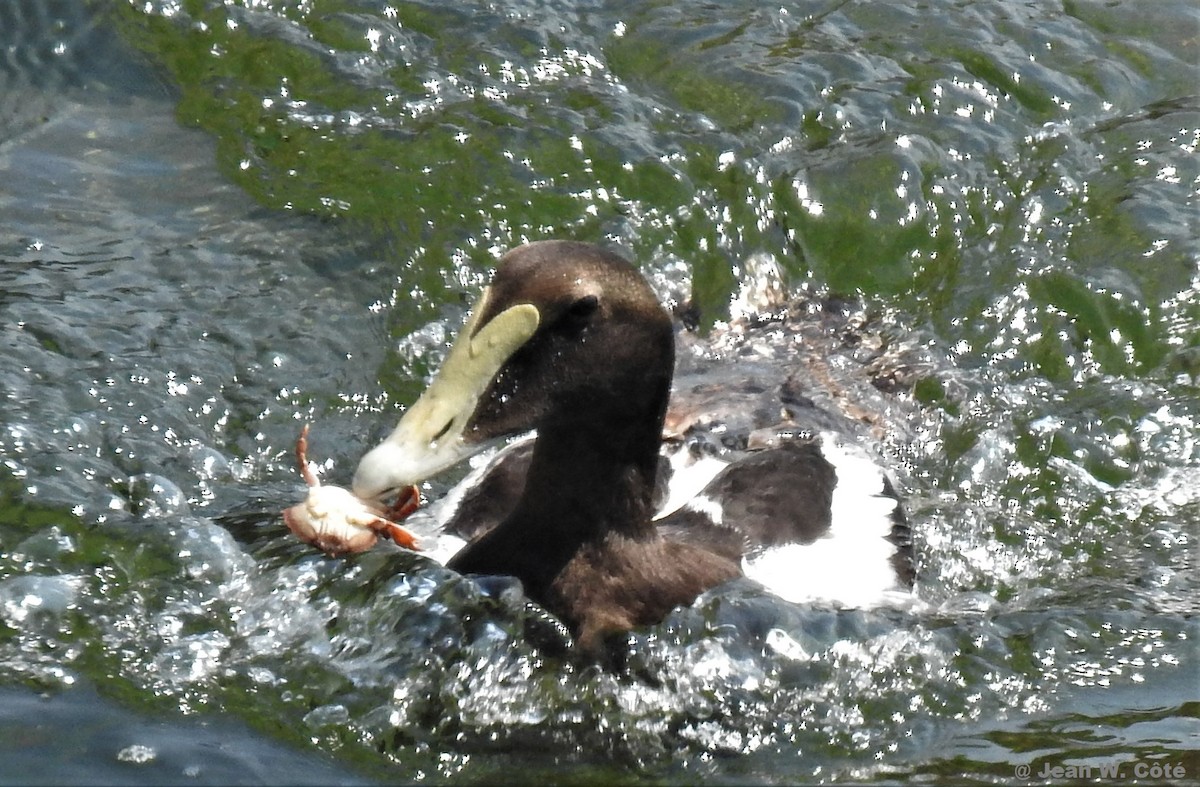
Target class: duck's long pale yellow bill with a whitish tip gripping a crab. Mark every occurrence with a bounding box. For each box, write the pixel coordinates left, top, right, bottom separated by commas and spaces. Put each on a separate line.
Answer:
353, 285, 540, 500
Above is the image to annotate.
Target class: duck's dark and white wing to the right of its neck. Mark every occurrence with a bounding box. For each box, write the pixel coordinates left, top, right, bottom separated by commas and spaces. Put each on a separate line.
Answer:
659, 434, 913, 607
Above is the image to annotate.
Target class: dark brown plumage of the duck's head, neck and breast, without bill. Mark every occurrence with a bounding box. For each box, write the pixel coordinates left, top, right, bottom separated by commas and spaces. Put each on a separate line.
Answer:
448, 241, 740, 650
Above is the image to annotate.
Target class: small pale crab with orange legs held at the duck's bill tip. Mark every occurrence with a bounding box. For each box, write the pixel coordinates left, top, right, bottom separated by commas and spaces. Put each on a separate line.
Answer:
283, 423, 421, 557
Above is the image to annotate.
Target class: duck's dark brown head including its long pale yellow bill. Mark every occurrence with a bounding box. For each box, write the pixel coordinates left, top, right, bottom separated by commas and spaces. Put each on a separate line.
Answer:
354, 241, 674, 499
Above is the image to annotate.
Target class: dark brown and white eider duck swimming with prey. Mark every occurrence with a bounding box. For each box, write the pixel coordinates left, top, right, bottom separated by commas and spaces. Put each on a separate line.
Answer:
353, 241, 912, 651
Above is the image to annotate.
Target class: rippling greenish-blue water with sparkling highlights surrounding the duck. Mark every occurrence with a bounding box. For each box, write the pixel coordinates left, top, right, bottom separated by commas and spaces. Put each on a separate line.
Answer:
0, 0, 1200, 783
